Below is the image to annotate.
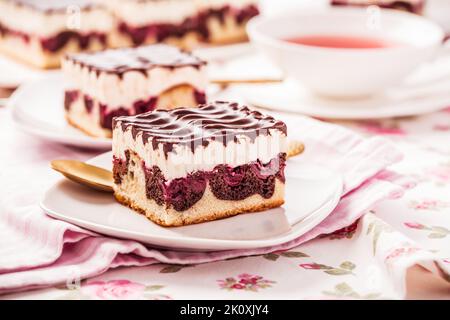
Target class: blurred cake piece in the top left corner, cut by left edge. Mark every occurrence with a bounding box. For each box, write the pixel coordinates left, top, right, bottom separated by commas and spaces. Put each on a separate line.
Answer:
0, 0, 112, 68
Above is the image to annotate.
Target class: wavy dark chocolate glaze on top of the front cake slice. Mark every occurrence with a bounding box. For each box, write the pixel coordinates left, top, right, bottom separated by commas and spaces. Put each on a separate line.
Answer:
113, 101, 287, 157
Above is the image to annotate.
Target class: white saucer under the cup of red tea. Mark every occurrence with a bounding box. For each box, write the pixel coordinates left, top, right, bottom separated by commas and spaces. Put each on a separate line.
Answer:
234, 56, 450, 119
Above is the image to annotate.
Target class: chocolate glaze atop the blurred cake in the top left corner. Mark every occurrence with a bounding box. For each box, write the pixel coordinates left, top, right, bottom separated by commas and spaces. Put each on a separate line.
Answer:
9, 0, 99, 13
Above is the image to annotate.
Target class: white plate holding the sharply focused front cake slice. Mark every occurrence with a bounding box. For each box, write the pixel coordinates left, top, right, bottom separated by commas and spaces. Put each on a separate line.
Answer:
41, 152, 342, 251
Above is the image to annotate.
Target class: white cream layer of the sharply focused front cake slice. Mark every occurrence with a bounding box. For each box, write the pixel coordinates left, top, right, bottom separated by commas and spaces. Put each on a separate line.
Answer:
112, 123, 287, 180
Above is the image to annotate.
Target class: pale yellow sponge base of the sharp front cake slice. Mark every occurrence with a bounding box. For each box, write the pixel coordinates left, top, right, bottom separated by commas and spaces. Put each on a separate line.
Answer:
114, 154, 284, 227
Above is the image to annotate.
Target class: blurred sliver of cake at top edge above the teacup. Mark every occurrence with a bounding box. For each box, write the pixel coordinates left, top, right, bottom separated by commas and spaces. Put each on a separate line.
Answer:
331, 0, 426, 14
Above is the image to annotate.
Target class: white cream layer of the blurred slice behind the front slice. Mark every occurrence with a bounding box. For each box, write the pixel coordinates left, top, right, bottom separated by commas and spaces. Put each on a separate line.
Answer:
62, 59, 208, 110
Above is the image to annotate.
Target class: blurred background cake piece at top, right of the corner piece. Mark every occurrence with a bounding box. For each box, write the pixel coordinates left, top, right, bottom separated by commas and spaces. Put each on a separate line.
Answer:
103, 0, 259, 49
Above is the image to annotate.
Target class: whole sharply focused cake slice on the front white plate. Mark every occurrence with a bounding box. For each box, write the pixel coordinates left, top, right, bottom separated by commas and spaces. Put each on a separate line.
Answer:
113, 102, 287, 226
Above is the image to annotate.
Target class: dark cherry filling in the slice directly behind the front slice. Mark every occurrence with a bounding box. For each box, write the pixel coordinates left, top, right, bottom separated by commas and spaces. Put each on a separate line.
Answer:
64, 90, 206, 130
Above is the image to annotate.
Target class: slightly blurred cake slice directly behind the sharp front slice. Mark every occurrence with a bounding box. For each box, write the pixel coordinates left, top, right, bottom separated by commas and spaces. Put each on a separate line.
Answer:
63, 44, 208, 137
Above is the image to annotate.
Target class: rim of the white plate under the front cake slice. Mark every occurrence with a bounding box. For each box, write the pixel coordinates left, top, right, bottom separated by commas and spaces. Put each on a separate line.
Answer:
39, 151, 343, 252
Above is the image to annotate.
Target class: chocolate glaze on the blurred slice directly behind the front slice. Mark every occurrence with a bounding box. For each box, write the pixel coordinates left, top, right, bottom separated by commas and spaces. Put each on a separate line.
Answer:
67, 44, 206, 76
